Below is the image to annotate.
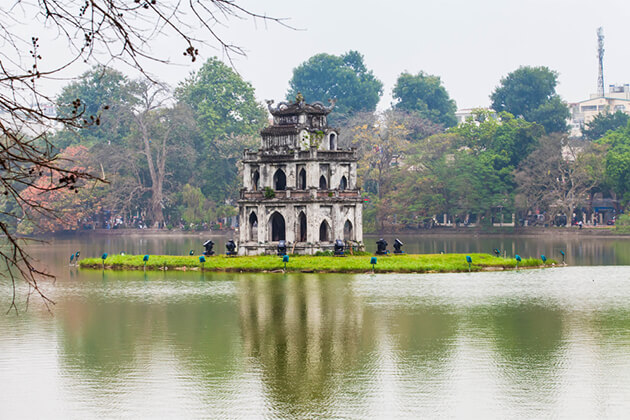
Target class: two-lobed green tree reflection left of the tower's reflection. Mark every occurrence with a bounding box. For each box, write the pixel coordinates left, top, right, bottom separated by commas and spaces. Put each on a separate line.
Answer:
59, 273, 240, 382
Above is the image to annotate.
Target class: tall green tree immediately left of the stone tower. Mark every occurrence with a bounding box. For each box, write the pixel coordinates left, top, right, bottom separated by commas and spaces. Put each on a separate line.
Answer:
176, 58, 267, 202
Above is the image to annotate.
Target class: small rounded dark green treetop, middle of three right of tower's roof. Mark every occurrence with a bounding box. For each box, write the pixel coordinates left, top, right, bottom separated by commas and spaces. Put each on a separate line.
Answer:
393, 71, 457, 128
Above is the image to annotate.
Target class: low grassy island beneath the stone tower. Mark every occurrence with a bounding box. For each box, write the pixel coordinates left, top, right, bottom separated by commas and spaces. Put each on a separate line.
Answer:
79, 254, 555, 273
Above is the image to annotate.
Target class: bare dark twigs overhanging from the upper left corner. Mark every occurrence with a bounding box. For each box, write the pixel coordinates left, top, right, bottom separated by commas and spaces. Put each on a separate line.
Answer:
0, 0, 284, 311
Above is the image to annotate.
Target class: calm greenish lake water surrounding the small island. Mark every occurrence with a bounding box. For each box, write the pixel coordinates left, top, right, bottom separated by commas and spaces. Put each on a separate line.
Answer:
0, 236, 630, 418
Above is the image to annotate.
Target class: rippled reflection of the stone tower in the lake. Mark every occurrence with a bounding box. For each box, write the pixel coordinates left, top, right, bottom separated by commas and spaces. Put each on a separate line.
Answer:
239, 275, 374, 417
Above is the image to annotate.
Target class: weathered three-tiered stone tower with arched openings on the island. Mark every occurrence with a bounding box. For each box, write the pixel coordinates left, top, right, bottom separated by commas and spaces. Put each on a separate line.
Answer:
238, 94, 363, 255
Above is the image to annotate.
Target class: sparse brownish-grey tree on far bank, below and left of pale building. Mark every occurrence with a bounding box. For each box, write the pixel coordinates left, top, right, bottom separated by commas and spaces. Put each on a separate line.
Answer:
516, 133, 604, 222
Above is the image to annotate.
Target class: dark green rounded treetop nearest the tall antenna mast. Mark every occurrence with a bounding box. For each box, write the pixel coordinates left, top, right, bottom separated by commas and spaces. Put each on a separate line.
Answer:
490, 66, 569, 133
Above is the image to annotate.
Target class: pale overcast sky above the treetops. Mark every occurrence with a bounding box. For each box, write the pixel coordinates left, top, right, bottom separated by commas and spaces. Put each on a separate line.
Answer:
14, 0, 630, 110
